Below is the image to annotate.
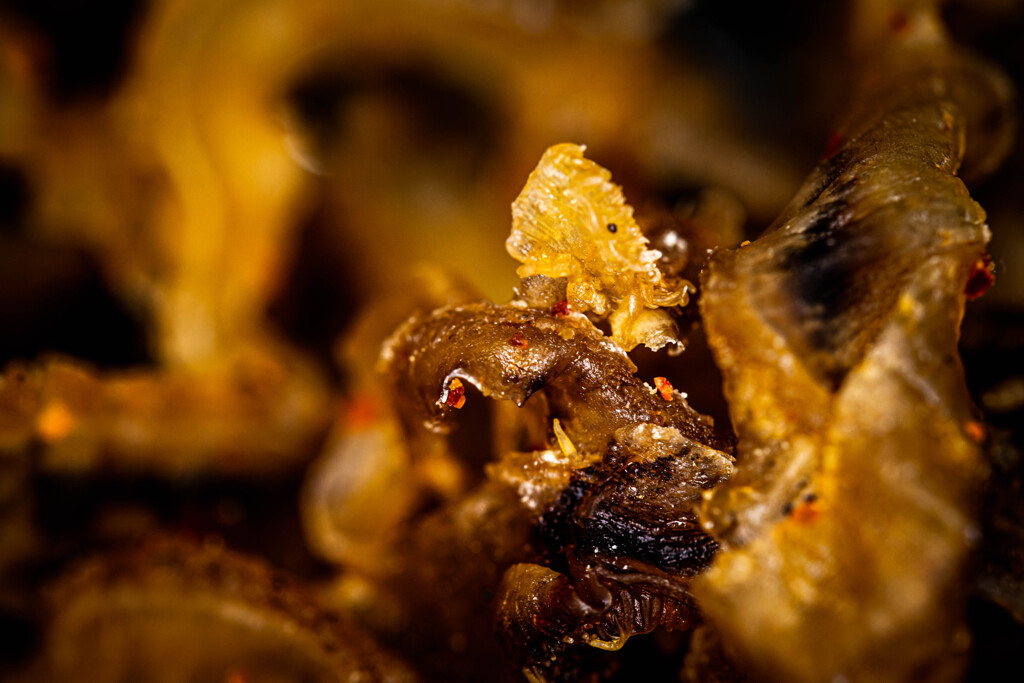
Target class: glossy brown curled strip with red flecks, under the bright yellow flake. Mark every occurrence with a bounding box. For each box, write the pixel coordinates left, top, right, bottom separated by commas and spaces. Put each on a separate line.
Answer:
382, 296, 725, 454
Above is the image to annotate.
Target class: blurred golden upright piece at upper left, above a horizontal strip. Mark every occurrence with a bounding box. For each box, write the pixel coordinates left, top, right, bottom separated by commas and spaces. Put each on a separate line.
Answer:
0, 0, 344, 367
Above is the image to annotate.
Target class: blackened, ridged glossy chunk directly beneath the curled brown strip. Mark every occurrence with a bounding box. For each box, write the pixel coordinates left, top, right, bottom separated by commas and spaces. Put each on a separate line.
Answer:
495, 424, 732, 681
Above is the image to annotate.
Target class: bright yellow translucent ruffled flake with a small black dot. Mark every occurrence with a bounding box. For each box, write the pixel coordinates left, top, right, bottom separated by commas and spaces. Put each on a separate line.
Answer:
505, 143, 693, 350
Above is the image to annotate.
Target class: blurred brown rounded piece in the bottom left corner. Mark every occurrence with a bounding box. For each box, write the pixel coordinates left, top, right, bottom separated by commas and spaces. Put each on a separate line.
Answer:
24, 541, 418, 683
